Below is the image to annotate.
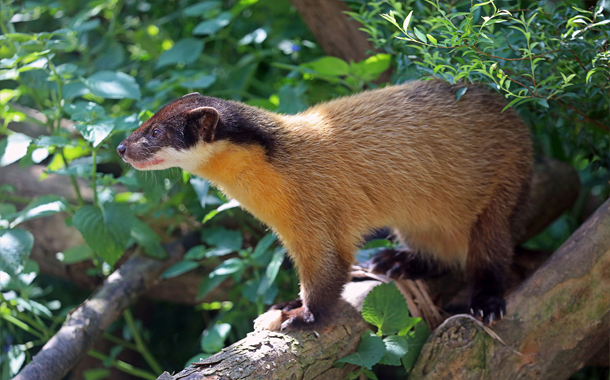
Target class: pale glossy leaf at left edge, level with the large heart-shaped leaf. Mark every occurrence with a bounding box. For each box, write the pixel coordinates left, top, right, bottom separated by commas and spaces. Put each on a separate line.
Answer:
0, 228, 34, 276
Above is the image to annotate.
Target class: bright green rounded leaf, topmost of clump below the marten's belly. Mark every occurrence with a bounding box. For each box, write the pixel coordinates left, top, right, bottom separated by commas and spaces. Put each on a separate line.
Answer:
362, 283, 409, 335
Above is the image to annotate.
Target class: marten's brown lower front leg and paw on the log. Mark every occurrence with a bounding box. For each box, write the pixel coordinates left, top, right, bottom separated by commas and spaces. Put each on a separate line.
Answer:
254, 248, 351, 331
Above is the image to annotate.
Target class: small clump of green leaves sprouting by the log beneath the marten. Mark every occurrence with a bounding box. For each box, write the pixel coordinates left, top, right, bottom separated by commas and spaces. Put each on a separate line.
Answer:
337, 282, 430, 379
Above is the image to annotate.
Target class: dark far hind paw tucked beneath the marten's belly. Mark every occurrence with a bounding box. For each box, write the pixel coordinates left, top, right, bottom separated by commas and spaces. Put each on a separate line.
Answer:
371, 247, 447, 280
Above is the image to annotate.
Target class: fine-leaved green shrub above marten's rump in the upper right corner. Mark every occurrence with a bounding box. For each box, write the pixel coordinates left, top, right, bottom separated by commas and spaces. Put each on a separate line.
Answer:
350, 0, 610, 220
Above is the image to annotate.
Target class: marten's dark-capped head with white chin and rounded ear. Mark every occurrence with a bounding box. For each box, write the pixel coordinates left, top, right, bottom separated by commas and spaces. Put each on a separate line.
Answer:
117, 93, 274, 170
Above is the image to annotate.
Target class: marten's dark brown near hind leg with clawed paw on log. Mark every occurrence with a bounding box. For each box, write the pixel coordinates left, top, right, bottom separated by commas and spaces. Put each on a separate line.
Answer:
466, 198, 513, 324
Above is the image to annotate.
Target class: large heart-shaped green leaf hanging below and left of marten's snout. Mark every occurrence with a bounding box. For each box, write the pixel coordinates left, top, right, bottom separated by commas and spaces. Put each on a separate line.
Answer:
72, 203, 136, 266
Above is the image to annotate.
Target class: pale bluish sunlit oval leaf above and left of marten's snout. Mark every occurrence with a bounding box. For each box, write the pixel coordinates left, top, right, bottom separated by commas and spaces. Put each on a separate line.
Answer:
85, 71, 141, 100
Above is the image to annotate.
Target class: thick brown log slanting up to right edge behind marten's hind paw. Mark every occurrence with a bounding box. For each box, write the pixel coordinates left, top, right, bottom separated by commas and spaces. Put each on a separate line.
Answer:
412, 200, 610, 380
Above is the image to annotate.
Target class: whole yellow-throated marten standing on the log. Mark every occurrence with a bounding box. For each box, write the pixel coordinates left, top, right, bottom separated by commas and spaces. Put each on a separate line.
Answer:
117, 80, 532, 330
